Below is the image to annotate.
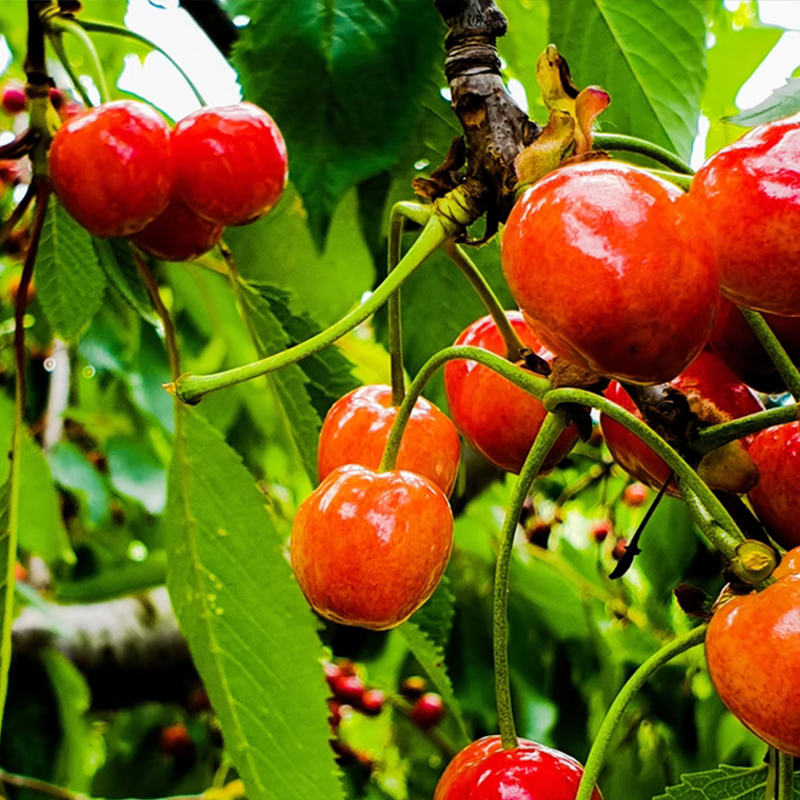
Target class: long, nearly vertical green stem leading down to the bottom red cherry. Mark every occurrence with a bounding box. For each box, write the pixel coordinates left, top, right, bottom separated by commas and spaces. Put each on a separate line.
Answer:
492, 412, 567, 749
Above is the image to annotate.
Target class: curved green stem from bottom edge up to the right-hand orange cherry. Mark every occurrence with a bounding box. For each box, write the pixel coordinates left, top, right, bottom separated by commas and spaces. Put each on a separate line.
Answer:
575, 625, 707, 800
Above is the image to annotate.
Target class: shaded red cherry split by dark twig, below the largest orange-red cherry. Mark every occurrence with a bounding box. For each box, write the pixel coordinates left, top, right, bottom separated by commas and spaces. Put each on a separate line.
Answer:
600, 350, 764, 495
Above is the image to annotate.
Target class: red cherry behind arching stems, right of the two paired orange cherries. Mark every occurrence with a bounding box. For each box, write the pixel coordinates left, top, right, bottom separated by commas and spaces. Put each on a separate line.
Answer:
444, 311, 578, 472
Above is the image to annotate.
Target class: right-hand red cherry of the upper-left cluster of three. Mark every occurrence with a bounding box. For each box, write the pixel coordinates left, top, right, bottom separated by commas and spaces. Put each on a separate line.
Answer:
172, 103, 288, 225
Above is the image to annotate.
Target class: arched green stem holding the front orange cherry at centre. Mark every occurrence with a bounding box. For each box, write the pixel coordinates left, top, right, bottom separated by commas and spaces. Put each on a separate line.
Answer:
379, 345, 550, 472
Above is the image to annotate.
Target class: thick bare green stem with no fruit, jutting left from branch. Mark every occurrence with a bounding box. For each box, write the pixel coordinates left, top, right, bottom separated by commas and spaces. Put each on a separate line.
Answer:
170, 206, 468, 405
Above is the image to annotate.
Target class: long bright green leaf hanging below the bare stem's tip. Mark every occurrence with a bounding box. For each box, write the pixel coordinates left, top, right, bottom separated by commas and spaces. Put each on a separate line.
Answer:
166, 408, 343, 800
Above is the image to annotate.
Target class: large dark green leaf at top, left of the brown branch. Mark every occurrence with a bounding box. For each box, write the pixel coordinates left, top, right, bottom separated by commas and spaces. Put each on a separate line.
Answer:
230, 0, 444, 247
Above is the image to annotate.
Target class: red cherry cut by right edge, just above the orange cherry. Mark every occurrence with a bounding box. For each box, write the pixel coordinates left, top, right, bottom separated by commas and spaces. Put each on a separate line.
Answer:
748, 422, 800, 547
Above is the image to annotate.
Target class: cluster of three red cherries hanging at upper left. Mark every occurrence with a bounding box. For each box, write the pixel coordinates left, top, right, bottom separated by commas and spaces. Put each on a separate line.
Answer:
49, 100, 287, 261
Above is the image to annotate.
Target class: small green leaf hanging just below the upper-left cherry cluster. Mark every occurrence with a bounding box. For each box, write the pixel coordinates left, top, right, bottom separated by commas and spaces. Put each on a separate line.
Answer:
34, 198, 106, 339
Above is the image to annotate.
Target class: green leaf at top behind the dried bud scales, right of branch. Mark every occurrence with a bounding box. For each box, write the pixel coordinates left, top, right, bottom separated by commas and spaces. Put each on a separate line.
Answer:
550, 0, 706, 159
